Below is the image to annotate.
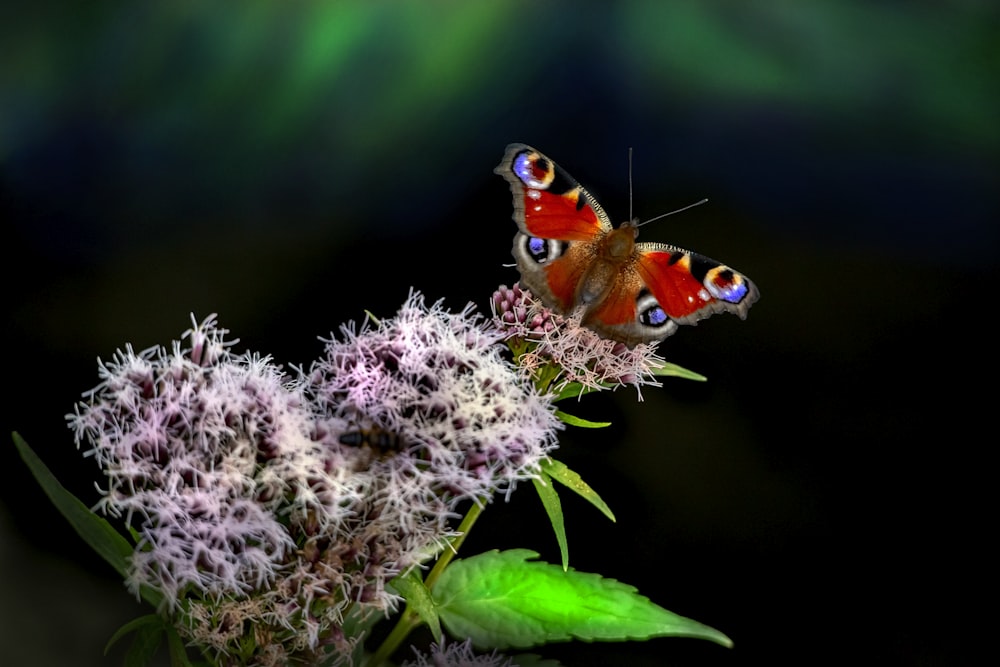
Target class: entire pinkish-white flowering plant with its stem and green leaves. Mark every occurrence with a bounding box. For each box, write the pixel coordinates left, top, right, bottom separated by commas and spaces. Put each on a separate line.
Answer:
15, 285, 729, 667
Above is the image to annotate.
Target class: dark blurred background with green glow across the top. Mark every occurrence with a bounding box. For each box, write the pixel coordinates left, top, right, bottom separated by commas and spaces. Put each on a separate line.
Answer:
0, 0, 1000, 666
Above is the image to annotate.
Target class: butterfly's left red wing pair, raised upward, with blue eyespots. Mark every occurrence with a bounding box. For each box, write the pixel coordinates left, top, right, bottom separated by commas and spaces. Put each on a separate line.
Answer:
494, 144, 612, 313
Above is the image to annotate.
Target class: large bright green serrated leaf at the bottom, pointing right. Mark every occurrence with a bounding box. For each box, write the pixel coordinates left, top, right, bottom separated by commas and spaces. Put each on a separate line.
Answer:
434, 549, 732, 649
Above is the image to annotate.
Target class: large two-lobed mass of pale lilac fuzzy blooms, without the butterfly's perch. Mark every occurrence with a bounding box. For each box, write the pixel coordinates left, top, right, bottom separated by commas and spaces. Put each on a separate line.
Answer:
68, 295, 560, 665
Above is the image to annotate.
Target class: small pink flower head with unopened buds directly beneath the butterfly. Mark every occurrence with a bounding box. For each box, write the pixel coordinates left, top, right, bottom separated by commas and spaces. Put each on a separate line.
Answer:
490, 283, 664, 400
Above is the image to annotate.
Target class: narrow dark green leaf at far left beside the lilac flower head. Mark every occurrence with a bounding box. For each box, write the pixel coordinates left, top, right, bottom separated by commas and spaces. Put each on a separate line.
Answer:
12, 432, 132, 577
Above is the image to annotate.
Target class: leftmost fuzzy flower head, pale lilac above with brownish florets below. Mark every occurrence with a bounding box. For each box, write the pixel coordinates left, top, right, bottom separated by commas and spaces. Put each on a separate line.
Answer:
69, 316, 382, 665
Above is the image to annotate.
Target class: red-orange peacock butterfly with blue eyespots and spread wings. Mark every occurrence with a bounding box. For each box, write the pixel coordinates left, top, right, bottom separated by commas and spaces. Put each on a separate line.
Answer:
494, 144, 760, 347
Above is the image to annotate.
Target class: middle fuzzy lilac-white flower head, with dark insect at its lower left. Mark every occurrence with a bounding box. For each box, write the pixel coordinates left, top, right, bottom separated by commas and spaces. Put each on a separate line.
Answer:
305, 294, 561, 504
